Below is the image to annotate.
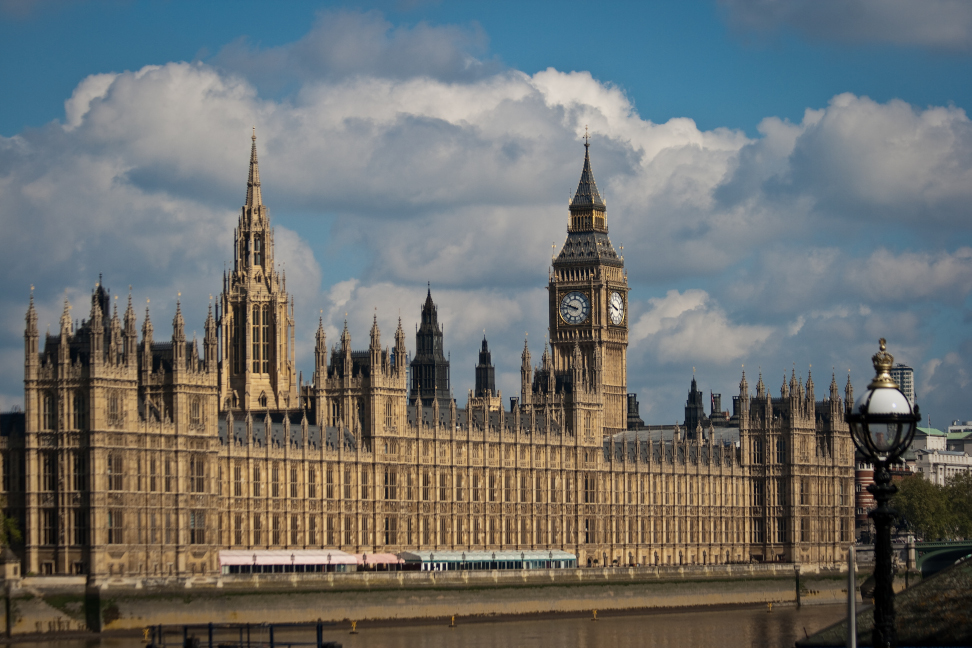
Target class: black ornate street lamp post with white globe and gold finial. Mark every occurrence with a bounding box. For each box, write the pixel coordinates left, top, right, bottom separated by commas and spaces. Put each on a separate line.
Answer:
846, 338, 921, 648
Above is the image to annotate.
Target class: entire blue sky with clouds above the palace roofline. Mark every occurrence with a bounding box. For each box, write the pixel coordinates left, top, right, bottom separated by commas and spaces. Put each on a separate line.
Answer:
0, 0, 972, 427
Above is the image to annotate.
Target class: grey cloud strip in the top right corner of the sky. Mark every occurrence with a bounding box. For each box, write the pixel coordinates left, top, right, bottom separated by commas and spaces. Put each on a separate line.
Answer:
719, 0, 972, 51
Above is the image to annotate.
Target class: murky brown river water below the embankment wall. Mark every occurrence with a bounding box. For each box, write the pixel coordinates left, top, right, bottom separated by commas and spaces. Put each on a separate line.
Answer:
11, 605, 846, 648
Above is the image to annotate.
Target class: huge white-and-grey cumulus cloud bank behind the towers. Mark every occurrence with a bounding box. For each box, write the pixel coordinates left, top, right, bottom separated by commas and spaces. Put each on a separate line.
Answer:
0, 13, 972, 420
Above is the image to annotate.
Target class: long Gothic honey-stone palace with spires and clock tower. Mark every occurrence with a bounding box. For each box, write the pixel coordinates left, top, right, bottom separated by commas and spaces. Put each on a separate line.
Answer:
0, 129, 854, 579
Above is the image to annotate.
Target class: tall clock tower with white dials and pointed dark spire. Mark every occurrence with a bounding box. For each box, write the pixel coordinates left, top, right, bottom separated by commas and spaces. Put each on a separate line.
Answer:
549, 136, 628, 435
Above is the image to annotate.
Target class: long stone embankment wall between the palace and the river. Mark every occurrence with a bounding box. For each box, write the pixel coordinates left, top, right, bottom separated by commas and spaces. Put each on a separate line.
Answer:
3, 565, 880, 634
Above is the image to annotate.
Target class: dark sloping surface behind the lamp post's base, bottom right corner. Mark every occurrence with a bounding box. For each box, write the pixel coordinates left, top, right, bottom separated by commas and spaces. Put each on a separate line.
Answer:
796, 560, 972, 648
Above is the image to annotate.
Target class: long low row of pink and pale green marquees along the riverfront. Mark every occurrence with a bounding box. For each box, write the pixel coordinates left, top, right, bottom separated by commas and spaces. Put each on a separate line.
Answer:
219, 549, 577, 575
